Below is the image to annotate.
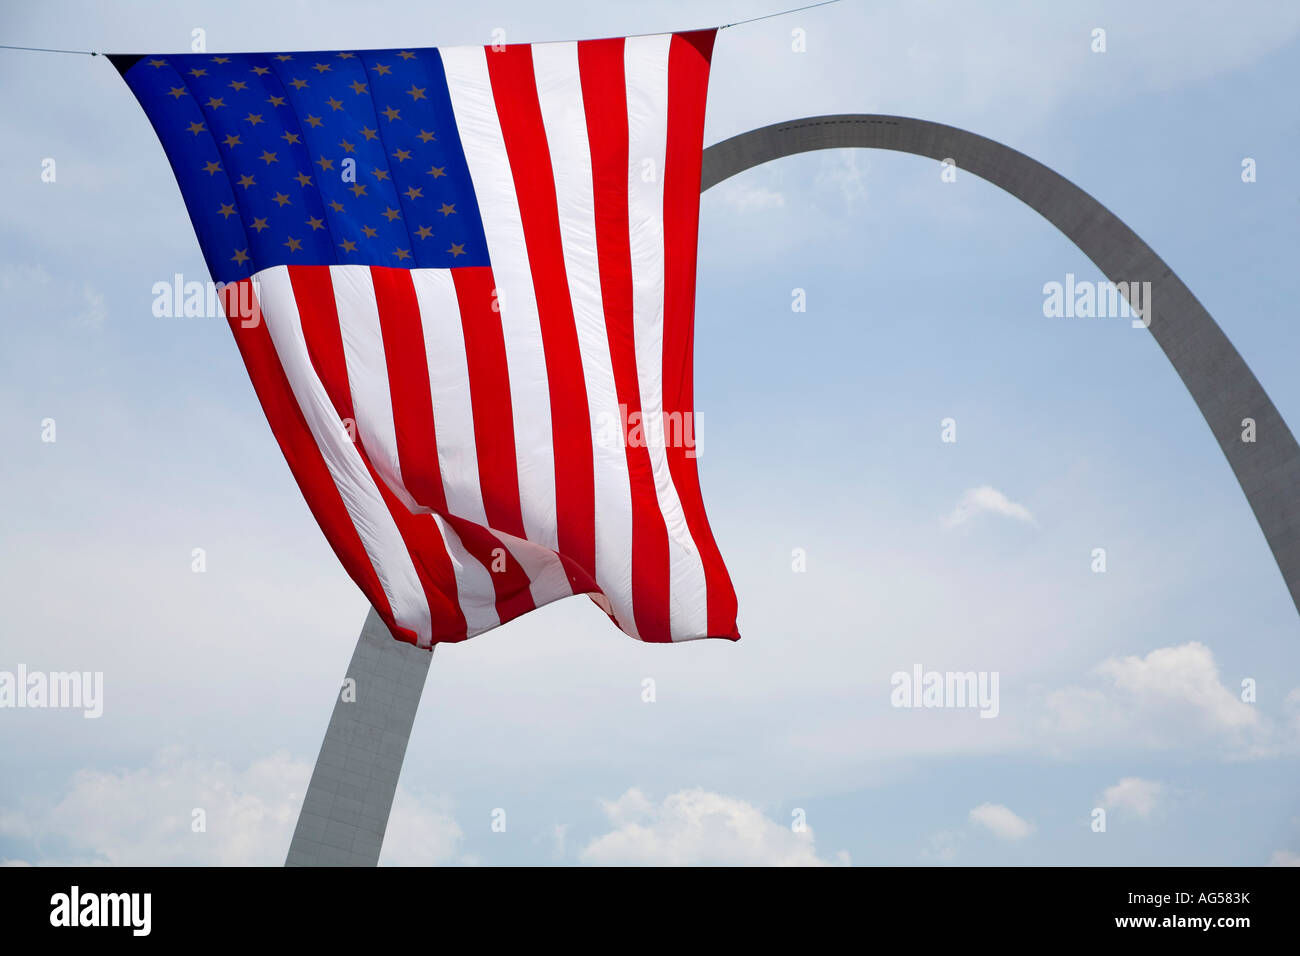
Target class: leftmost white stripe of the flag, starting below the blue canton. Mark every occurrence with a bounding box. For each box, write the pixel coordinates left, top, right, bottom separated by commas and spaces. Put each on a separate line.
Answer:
254, 265, 433, 648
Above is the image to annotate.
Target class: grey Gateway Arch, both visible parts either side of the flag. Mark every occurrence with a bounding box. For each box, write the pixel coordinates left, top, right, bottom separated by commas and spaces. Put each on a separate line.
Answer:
286, 113, 1300, 866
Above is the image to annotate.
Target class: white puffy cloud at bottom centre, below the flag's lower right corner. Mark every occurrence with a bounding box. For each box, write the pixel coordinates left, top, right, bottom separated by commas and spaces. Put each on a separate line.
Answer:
579, 787, 849, 866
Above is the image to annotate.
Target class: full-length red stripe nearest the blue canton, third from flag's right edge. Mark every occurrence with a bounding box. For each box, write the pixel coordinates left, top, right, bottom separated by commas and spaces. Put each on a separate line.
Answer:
486, 44, 597, 593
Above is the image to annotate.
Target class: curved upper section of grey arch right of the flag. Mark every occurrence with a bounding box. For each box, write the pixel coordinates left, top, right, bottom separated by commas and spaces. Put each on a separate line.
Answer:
699, 113, 1300, 621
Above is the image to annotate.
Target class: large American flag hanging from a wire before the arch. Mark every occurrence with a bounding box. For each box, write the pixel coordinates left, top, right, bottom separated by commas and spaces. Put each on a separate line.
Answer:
113, 30, 738, 646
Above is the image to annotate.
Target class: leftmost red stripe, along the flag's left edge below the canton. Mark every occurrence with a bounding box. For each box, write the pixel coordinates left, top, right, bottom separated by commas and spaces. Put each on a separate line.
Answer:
222, 278, 416, 644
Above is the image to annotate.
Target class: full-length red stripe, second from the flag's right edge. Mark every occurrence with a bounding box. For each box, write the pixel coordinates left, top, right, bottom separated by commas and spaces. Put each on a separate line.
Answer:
577, 38, 672, 641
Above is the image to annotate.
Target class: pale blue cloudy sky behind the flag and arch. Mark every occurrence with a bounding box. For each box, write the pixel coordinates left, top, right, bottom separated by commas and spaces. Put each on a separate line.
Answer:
0, 0, 1300, 866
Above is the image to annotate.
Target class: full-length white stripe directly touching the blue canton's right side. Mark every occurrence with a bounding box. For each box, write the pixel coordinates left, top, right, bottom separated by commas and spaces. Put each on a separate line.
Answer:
442, 47, 559, 567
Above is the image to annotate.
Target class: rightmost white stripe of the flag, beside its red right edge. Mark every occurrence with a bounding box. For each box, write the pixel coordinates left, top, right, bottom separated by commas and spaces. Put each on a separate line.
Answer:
623, 35, 709, 640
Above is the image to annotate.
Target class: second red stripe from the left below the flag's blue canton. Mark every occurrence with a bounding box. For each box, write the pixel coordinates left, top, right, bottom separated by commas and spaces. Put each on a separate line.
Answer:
289, 265, 467, 643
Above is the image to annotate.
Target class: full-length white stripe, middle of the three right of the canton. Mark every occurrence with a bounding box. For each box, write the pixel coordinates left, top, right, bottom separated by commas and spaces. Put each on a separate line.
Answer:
533, 43, 637, 637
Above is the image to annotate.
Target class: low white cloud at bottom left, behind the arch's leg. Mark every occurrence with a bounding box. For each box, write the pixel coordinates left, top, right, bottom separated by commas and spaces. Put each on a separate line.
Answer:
0, 749, 460, 866
